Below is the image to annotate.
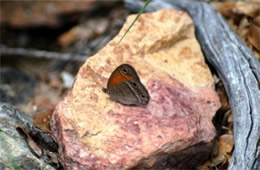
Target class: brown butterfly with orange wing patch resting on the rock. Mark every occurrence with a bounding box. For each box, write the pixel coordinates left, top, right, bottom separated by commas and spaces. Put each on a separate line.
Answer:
103, 64, 150, 105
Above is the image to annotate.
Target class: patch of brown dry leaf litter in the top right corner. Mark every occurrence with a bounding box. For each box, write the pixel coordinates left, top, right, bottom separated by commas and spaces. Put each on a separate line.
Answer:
212, 1, 260, 60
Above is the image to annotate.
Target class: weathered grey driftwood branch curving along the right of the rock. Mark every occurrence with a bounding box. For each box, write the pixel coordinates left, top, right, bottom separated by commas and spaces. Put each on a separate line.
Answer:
125, 0, 260, 170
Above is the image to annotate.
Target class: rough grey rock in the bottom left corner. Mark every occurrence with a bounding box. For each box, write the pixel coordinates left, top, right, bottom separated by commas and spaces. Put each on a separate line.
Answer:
0, 104, 55, 170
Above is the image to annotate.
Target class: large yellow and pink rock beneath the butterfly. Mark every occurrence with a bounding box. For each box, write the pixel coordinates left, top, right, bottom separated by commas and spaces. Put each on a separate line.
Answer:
52, 9, 220, 169
